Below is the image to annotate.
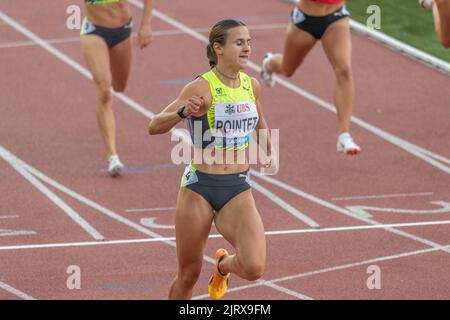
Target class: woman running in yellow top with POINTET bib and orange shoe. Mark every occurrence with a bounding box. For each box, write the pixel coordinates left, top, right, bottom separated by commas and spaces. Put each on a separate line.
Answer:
149, 20, 276, 299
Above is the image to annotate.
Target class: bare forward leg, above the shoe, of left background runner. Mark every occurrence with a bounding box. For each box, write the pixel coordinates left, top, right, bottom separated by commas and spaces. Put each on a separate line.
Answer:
81, 35, 116, 157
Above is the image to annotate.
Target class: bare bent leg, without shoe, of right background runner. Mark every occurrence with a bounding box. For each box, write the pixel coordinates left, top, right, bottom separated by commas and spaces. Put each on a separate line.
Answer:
265, 22, 317, 77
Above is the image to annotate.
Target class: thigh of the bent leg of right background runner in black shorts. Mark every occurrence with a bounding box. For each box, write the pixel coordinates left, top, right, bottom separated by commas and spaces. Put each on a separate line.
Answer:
282, 22, 317, 73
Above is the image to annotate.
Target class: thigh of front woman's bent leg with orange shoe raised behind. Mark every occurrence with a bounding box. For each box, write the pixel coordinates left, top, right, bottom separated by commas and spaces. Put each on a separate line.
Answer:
214, 189, 266, 259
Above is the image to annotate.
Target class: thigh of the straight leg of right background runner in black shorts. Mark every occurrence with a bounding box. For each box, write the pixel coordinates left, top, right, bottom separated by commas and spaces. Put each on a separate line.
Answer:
322, 18, 352, 67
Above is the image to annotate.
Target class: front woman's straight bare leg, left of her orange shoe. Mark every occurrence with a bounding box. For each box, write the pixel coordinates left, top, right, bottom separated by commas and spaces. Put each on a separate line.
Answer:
169, 188, 214, 300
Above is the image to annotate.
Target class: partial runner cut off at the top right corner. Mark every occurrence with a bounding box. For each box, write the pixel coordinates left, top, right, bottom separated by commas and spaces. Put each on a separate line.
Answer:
419, 0, 450, 48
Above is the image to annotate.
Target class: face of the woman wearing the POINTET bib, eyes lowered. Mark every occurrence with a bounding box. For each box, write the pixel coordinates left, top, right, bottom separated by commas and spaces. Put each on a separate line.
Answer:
218, 26, 251, 69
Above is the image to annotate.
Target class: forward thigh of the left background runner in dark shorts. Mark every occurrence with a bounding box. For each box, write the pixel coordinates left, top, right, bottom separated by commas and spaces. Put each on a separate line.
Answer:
81, 35, 111, 85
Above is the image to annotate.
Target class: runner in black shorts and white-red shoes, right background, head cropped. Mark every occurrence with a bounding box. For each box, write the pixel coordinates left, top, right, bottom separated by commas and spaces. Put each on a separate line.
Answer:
261, 0, 361, 155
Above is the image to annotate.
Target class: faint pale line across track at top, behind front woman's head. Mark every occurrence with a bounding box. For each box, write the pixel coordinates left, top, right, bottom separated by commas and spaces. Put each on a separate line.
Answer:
0, 24, 286, 49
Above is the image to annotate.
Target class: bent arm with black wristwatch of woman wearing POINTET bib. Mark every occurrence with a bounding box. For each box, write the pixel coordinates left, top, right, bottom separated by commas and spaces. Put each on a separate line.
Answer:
148, 79, 209, 135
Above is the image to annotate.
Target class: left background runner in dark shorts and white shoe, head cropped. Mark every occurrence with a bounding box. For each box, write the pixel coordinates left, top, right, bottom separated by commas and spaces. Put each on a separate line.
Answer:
80, 0, 152, 176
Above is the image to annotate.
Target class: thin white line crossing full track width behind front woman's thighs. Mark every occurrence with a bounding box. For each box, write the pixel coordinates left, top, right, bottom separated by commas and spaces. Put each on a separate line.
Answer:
4, 220, 450, 251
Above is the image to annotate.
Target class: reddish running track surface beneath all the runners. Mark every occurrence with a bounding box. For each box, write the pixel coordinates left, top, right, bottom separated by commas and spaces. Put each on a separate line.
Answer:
0, 0, 450, 299
